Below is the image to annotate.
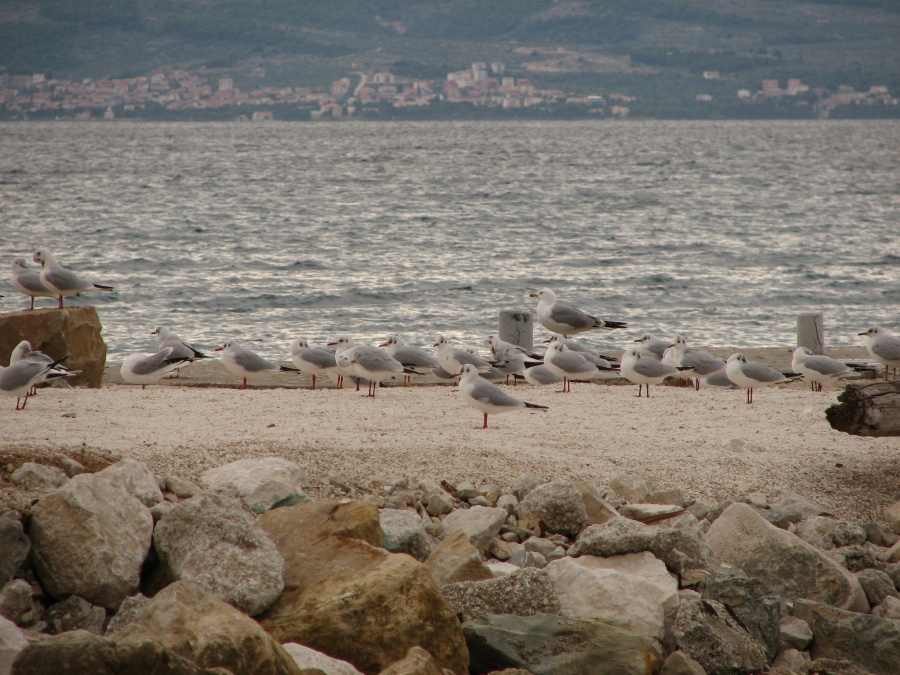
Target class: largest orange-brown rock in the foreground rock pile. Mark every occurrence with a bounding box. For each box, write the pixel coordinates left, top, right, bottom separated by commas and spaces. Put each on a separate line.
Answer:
260, 501, 469, 673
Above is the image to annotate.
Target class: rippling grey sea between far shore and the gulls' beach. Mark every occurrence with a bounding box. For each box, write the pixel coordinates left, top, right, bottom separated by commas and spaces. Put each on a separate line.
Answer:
0, 120, 900, 360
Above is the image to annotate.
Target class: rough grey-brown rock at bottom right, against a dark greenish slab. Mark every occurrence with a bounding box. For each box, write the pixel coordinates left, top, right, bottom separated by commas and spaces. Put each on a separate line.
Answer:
674, 600, 768, 675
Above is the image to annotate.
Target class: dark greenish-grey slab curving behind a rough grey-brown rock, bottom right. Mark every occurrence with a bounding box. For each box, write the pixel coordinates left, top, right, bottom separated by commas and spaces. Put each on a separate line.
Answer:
702, 572, 781, 663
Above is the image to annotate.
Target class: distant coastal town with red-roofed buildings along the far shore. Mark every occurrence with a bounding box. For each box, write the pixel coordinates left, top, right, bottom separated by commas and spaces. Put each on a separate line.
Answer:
0, 61, 900, 121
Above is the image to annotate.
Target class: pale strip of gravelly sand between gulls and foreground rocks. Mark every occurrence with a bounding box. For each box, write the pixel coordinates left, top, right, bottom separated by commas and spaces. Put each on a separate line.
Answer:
0, 354, 900, 523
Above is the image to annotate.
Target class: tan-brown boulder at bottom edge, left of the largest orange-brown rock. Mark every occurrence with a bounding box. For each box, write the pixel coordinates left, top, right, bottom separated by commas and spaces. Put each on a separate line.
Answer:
115, 581, 300, 675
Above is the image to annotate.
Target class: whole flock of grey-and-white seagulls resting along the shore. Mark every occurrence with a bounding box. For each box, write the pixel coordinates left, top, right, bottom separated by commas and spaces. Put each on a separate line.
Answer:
0, 248, 900, 428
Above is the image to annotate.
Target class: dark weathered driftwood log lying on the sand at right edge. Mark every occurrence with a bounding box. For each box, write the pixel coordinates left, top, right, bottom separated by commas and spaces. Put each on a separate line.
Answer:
825, 382, 900, 436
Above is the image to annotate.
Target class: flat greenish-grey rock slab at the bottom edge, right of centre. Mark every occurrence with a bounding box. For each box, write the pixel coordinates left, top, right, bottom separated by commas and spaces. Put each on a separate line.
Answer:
463, 614, 662, 675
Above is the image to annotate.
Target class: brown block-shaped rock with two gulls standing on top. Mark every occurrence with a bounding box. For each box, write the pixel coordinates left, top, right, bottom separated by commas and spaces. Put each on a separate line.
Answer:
0, 306, 106, 389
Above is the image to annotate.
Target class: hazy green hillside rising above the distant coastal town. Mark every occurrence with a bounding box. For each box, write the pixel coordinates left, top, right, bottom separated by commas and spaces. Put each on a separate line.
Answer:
0, 0, 900, 117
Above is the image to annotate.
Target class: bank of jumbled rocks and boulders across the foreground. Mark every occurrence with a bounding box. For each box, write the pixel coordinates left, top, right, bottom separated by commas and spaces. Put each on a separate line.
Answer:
0, 457, 900, 675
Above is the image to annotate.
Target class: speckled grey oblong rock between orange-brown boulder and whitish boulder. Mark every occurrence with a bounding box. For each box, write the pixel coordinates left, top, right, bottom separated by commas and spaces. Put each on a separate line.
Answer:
441, 567, 560, 621
